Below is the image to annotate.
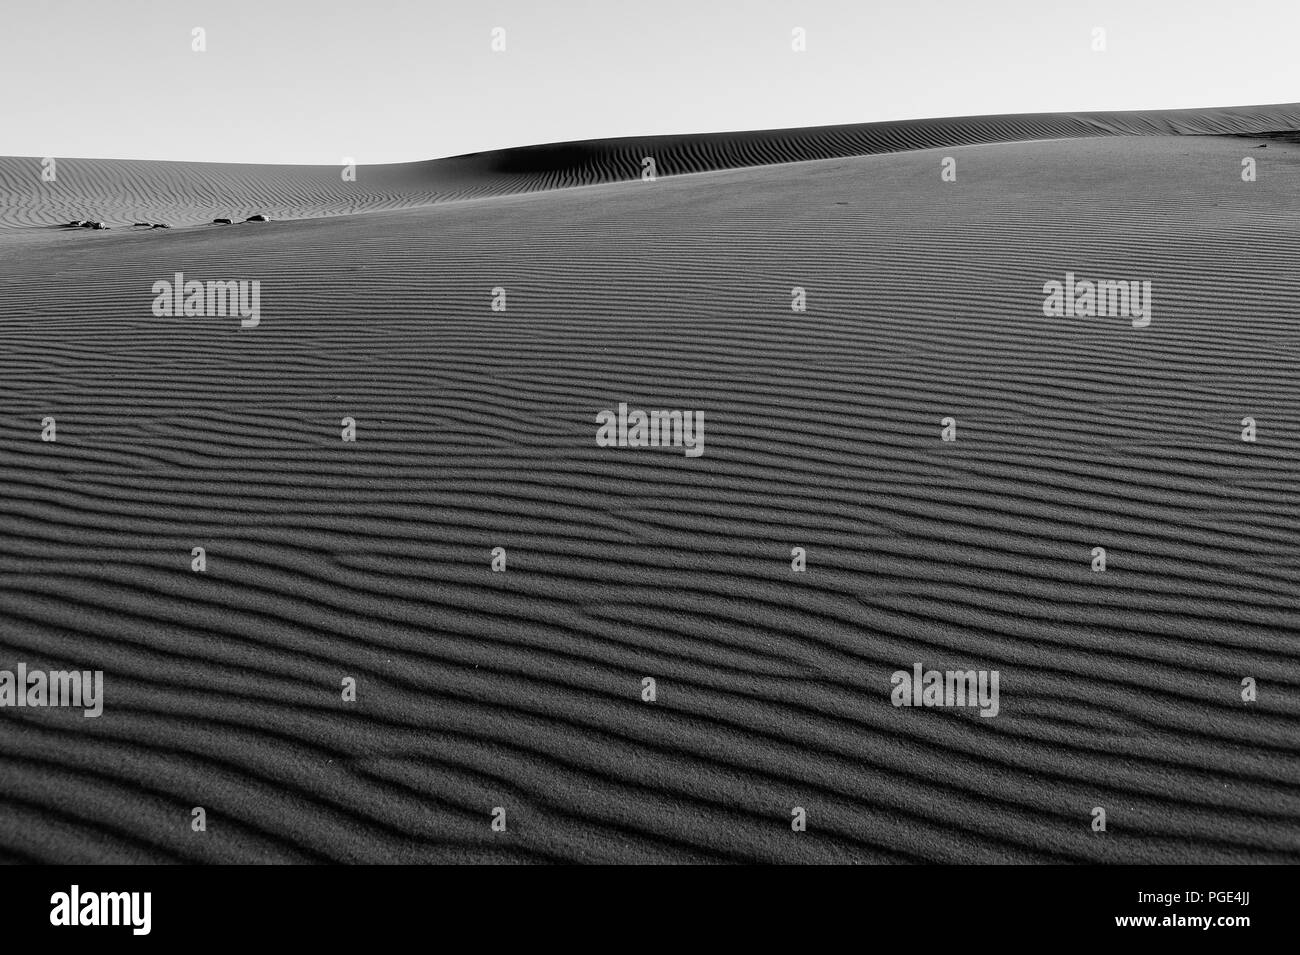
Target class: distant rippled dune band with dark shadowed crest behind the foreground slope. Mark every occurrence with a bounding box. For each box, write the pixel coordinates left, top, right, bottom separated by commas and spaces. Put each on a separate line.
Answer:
0, 104, 1300, 229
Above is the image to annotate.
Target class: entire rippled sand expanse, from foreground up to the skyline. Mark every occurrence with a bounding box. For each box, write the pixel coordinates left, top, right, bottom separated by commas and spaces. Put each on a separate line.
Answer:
0, 107, 1300, 863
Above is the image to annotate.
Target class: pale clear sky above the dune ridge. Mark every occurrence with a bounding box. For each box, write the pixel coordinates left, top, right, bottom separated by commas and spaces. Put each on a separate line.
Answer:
0, 0, 1300, 165
